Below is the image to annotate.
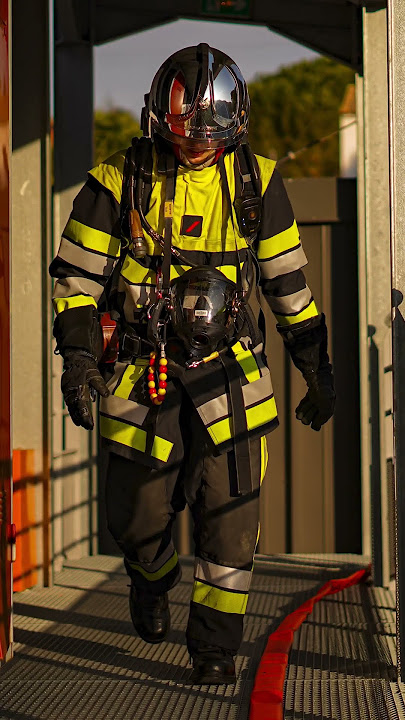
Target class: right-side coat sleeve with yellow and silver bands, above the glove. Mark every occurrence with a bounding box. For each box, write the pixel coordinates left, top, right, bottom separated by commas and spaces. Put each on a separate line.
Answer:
257, 170, 319, 329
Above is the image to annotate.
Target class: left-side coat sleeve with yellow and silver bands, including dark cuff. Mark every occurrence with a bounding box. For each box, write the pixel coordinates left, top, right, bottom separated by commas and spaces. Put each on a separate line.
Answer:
49, 156, 122, 356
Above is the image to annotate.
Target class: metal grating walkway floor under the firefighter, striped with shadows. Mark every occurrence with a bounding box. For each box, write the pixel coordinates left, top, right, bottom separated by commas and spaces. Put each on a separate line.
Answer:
0, 556, 405, 720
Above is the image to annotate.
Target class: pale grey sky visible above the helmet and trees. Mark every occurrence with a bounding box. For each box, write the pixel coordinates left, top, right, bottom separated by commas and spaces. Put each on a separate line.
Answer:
94, 20, 318, 117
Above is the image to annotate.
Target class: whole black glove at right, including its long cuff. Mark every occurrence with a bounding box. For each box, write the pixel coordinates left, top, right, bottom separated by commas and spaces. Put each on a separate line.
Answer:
277, 314, 336, 430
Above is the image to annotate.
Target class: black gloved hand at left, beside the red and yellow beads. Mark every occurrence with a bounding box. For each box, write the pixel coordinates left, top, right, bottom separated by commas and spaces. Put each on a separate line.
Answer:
61, 350, 110, 430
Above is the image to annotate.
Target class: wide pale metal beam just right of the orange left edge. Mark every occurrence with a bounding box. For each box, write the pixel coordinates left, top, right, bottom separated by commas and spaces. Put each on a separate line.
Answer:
11, 0, 50, 583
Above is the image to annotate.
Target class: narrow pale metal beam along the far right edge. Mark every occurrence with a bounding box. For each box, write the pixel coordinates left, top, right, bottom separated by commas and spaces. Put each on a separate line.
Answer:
388, 0, 405, 680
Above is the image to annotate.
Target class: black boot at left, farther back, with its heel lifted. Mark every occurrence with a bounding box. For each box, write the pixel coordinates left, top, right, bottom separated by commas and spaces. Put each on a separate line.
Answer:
129, 582, 170, 644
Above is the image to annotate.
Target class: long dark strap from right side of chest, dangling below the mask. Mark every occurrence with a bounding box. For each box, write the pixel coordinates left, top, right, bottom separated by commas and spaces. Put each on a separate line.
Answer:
218, 155, 253, 495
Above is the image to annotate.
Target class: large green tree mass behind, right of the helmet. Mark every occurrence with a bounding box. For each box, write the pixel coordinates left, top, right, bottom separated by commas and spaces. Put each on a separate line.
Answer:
249, 58, 354, 177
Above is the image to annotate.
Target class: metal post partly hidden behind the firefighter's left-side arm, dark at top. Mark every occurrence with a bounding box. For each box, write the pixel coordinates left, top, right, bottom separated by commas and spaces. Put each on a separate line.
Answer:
52, 0, 97, 568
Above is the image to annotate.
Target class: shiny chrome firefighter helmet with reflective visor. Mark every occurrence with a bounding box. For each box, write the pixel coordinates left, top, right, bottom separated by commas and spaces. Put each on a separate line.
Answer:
142, 43, 250, 150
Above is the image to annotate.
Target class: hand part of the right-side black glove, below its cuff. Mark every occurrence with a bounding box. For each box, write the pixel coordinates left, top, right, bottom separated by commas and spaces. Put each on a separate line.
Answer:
295, 373, 336, 430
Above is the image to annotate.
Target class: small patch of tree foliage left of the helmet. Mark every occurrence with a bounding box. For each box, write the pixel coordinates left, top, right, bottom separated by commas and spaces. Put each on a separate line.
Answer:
94, 108, 142, 165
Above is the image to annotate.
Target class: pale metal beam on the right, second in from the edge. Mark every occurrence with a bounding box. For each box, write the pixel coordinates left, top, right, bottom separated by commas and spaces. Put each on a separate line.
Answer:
360, 8, 391, 585
